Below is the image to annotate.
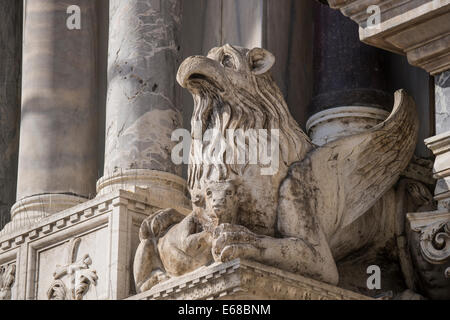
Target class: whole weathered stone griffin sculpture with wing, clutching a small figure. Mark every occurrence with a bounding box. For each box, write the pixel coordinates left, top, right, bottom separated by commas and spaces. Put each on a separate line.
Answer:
134, 45, 418, 292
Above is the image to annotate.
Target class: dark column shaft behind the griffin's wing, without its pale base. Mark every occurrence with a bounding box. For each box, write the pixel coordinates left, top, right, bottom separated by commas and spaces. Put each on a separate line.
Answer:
311, 3, 393, 113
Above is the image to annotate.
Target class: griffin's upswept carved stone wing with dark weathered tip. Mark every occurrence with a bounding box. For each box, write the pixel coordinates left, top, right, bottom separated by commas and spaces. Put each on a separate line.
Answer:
293, 90, 419, 232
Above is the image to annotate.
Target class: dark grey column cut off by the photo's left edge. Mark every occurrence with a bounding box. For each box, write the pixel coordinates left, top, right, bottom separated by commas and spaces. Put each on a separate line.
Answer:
0, 1, 22, 230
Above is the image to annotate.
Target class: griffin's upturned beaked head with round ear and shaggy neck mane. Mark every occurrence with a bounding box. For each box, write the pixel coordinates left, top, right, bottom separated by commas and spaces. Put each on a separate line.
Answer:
177, 44, 312, 190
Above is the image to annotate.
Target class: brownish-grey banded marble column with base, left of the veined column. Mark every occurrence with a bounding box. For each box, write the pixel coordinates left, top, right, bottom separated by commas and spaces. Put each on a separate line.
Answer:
7, 0, 97, 228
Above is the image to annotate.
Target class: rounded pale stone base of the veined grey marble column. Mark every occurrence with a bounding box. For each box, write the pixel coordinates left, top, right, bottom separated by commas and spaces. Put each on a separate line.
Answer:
97, 169, 190, 211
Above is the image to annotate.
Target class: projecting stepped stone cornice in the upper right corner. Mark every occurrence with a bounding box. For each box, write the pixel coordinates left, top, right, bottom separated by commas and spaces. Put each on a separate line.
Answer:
328, 0, 450, 75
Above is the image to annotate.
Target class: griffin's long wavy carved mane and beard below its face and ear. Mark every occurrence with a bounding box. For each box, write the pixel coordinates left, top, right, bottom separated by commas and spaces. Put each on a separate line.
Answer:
188, 73, 312, 189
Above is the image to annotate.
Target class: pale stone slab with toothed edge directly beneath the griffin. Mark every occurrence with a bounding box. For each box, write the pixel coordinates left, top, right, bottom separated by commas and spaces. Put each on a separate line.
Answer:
129, 259, 371, 300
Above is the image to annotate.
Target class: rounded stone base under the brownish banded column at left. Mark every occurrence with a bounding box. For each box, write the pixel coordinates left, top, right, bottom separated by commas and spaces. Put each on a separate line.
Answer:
0, 194, 88, 235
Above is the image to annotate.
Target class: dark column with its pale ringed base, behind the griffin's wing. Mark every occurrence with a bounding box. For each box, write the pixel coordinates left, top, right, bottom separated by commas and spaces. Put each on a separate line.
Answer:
306, 2, 393, 145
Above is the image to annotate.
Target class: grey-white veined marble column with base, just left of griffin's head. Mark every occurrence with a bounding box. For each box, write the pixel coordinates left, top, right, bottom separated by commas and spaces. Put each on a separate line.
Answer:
97, 0, 185, 205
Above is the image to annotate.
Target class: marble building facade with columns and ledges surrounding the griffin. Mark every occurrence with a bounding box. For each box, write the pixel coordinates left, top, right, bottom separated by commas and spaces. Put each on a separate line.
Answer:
0, 0, 450, 300
